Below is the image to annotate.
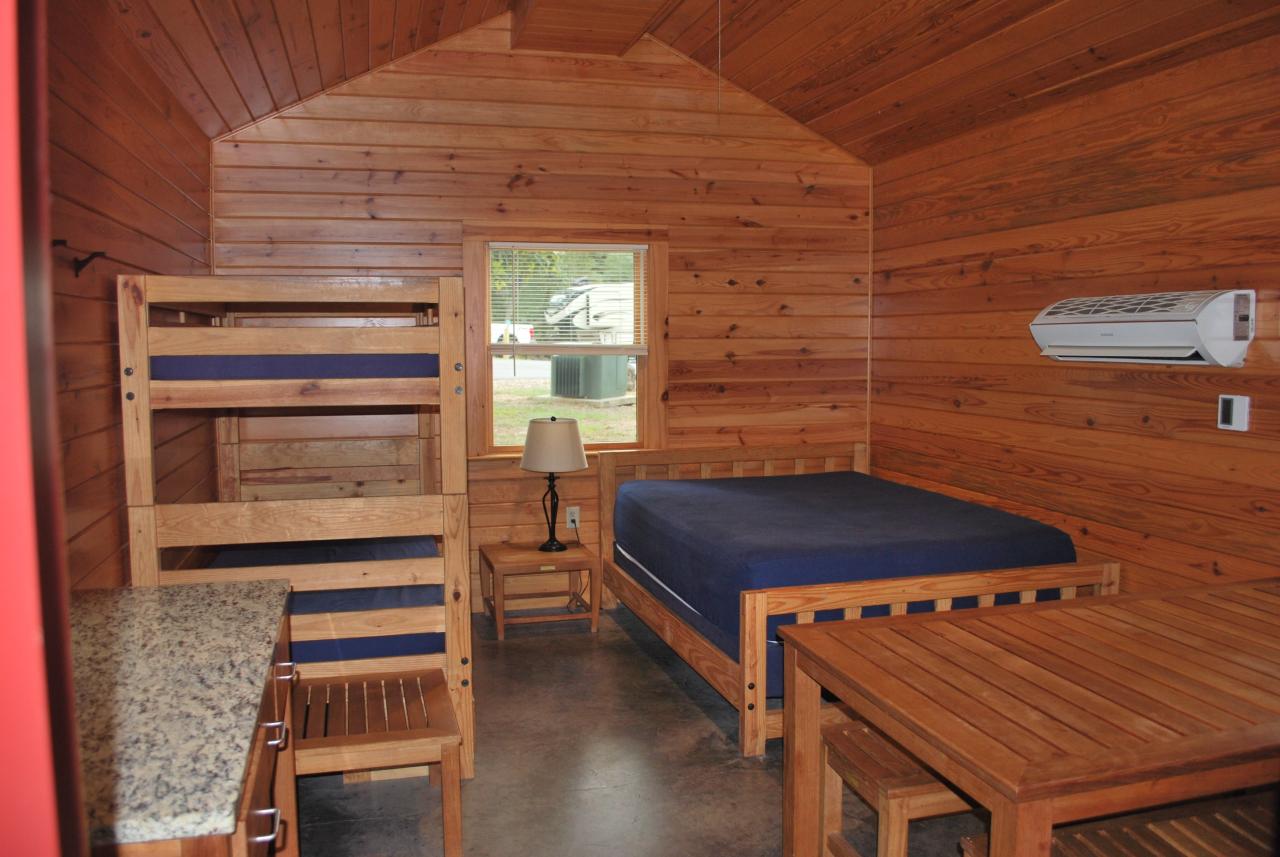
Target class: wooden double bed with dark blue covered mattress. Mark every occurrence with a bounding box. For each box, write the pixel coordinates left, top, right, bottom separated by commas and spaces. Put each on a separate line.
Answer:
600, 444, 1119, 755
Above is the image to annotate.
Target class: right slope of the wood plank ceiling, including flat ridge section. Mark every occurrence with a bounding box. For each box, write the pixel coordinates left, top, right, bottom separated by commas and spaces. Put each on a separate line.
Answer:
515, 0, 1280, 164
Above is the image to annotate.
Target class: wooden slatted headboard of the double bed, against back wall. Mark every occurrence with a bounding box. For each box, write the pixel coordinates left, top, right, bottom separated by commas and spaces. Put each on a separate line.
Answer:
599, 443, 869, 560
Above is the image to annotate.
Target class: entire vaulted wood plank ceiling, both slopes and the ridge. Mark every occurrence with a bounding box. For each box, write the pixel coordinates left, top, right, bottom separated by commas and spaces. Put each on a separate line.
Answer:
102, 0, 1280, 164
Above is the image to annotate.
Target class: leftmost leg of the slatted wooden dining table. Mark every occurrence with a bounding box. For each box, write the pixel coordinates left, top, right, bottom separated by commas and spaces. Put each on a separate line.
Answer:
782, 646, 823, 857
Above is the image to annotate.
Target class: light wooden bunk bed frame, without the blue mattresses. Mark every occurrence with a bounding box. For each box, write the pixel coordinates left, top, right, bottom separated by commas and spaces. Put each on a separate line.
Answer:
119, 275, 475, 776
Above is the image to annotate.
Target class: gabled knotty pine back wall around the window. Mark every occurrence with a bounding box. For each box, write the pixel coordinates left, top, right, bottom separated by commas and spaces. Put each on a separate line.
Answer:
214, 15, 869, 603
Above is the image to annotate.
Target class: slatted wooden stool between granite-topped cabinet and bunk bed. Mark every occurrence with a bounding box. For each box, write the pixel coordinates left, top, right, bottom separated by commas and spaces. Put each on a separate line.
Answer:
293, 669, 462, 857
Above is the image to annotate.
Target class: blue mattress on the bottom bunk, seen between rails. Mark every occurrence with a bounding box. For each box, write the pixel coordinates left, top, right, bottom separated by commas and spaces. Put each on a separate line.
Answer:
210, 536, 444, 664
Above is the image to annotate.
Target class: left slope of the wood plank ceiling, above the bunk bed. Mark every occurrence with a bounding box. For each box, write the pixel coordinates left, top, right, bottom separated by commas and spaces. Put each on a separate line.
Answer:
97, 0, 508, 137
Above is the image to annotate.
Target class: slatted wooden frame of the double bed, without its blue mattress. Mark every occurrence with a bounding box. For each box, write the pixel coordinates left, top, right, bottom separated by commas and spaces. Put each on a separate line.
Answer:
599, 444, 1120, 756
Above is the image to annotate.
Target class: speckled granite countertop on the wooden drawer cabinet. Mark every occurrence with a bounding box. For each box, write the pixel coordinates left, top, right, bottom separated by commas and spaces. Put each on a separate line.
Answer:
70, 581, 288, 844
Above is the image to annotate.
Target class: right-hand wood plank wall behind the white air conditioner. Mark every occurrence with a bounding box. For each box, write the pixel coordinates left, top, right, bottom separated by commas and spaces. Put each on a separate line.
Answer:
872, 37, 1280, 598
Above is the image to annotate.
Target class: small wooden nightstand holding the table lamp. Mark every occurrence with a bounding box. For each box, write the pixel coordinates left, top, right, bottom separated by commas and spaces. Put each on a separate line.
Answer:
480, 541, 602, 640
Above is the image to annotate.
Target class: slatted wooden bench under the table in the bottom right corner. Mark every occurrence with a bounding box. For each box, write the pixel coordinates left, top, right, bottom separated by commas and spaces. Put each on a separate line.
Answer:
960, 790, 1280, 857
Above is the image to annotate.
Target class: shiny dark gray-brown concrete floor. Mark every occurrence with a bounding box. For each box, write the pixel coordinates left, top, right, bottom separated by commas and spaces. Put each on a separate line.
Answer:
300, 609, 983, 857
